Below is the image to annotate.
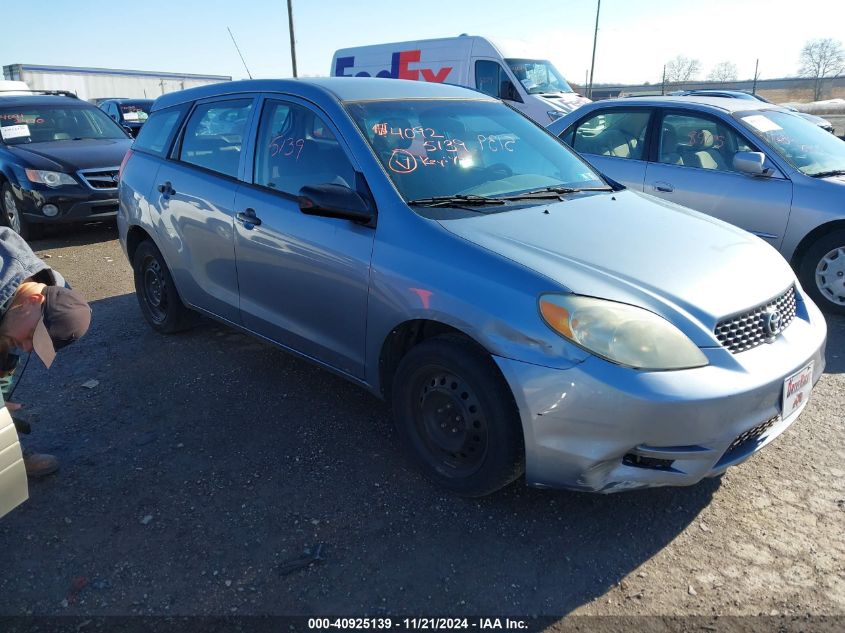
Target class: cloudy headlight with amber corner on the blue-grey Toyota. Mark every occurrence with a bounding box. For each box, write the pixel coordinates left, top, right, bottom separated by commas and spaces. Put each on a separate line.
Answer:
540, 294, 707, 370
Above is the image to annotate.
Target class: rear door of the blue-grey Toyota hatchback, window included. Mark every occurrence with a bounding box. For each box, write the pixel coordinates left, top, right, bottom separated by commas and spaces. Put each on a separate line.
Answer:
150, 94, 256, 323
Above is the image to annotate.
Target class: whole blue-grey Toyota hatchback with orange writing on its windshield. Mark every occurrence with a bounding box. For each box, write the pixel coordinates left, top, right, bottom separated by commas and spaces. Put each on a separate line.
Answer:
118, 78, 826, 495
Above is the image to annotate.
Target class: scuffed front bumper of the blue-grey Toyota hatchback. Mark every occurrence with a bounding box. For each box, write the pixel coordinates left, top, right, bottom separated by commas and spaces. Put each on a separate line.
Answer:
495, 300, 827, 493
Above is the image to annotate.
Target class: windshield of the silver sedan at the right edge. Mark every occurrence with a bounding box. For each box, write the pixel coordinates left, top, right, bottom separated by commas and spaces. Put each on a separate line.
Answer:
734, 110, 845, 176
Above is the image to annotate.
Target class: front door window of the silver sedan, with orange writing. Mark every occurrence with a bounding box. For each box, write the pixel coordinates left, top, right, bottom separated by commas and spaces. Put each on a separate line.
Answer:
657, 114, 754, 171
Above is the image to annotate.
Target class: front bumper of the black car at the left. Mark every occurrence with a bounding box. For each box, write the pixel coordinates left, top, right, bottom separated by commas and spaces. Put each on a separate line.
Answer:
12, 183, 118, 224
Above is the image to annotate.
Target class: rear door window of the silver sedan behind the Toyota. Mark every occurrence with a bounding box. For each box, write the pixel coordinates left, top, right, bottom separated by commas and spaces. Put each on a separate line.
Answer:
572, 109, 651, 160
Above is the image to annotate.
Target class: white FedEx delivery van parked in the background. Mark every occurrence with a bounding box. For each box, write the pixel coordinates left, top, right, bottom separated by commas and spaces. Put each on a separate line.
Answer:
331, 35, 590, 126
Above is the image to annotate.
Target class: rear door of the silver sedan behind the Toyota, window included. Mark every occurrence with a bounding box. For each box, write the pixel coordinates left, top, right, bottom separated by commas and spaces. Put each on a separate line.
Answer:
561, 107, 654, 191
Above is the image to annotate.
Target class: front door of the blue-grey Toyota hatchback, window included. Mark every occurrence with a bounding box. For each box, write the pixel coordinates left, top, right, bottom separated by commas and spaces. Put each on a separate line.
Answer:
235, 99, 375, 378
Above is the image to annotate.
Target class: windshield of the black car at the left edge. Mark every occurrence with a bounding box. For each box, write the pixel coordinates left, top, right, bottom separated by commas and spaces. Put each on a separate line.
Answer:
0, 105, 126, 145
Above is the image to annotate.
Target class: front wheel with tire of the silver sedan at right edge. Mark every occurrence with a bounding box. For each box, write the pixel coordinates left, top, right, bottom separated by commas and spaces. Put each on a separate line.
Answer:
798, 230, 845, 314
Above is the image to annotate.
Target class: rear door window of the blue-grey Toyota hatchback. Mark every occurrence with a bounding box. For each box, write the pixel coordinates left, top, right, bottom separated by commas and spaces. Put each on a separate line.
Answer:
178, 99, 252, 178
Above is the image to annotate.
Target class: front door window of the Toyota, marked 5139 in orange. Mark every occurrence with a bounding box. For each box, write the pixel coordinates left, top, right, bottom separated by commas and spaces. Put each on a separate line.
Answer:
253, 101, 355, 196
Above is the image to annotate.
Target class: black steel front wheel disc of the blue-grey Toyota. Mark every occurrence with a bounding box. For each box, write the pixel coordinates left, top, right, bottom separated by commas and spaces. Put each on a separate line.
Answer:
411, 366, 489, 479
